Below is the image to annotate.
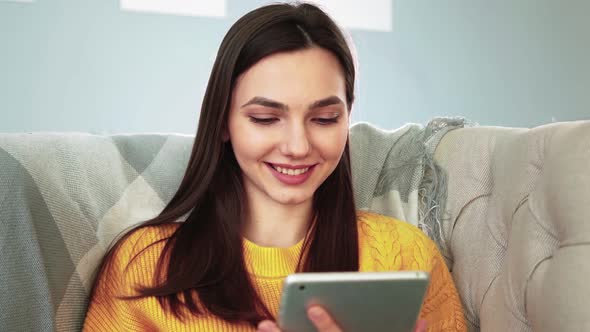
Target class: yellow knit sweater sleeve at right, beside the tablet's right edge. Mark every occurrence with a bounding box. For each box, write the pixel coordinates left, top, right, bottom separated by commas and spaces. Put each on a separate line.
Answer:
419, 241, 467, 332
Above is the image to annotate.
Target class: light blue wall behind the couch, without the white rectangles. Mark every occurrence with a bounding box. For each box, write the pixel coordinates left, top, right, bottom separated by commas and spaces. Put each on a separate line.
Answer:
0, 0, 590, 133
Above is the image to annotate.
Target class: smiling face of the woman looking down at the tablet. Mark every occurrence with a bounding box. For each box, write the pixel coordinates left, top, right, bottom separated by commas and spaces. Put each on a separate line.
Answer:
228, 47, 349, 205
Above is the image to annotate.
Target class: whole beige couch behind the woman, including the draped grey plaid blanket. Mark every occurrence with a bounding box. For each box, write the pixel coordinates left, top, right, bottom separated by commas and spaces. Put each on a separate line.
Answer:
0, 121, 590, 331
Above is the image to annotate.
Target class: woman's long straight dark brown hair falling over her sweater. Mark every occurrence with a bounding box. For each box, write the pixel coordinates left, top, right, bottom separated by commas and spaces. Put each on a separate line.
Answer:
92, 4, 359, 325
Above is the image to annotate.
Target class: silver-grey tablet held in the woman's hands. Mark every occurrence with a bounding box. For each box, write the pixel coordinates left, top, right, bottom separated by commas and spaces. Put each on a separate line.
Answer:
278, 271, 429, 332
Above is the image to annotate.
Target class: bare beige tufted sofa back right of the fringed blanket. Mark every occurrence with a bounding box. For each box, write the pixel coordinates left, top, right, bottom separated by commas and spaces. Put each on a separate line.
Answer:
435, 121, 590, 332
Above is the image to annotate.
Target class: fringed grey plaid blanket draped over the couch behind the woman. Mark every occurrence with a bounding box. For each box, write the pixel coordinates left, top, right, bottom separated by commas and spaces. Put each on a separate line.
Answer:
0, 119, 463, 331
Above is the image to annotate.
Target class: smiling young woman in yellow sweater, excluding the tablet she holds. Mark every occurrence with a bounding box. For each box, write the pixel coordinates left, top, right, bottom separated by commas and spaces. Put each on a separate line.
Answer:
84, 4, 465, 331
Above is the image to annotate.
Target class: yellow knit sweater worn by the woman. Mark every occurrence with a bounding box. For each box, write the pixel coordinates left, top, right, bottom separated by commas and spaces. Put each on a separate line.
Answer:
84, 213, 466, 331
